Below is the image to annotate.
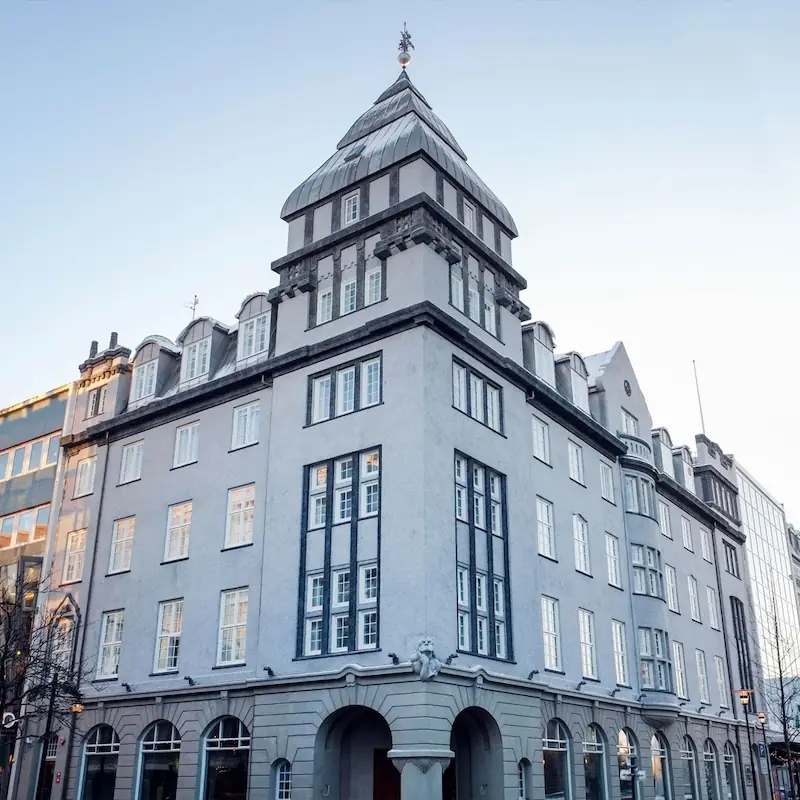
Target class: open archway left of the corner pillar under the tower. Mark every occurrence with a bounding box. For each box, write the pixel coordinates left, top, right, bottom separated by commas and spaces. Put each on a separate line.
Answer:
314, 706, 400, 800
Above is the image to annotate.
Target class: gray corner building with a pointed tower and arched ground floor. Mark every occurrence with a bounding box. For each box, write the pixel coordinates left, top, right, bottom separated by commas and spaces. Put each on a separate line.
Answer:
17, 67, 755, 800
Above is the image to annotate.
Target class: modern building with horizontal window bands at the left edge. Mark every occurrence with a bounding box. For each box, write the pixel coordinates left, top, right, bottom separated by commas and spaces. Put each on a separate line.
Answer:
0, 386, 69, 797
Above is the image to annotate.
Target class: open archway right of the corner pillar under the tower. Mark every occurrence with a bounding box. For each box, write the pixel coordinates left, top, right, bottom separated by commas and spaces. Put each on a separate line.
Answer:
444, 707, 503, 800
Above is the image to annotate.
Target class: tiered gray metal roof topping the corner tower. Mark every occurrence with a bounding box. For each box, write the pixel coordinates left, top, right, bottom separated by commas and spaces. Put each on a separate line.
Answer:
281, 71, 517, 235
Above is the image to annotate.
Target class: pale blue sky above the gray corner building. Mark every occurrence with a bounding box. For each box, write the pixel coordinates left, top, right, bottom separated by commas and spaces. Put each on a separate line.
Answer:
0, 0, 800, 523
